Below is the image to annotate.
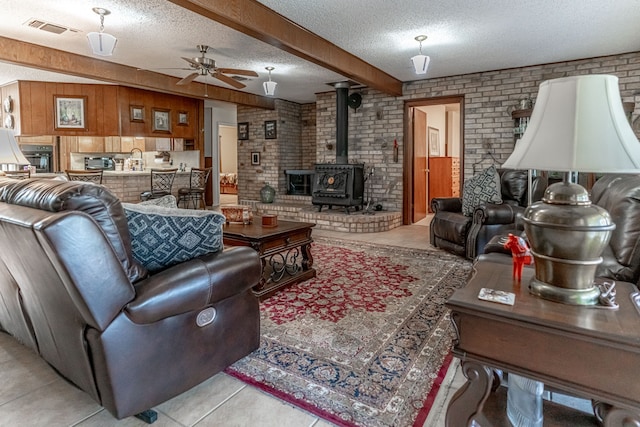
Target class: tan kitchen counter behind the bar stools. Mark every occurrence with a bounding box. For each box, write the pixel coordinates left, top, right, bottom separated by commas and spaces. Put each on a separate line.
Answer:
32, 168, 191, 203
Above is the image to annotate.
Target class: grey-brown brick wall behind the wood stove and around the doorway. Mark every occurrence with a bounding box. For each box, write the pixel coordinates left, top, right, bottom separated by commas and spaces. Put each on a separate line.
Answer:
238, 52, 640, 210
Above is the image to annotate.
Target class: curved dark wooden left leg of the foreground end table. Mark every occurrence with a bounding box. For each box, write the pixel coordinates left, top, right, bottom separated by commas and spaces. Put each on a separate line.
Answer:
444, 360, 494, 427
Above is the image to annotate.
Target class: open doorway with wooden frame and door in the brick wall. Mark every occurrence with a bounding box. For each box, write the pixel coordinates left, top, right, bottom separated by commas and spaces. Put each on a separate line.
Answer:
403, 96, 464, 225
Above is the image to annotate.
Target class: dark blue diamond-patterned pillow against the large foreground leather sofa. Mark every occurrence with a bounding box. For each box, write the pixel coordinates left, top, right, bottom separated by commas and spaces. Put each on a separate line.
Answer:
122, 203, 225, 273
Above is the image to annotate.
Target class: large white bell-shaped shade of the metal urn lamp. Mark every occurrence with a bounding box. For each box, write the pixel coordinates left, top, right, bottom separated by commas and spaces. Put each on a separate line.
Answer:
502, 75, 640, 173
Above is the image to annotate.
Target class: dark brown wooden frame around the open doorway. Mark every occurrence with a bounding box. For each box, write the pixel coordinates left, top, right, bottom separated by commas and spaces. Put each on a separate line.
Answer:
402, 95, 465, 225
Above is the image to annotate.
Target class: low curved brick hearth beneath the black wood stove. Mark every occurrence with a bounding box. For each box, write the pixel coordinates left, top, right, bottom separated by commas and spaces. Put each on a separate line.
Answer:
240, 195, 402, 233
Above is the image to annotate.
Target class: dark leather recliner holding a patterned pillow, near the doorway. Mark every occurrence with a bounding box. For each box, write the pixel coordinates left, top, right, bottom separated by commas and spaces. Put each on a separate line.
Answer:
429, 169, 547, 259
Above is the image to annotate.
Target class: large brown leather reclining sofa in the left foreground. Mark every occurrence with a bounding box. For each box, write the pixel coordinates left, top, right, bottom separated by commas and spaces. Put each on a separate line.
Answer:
0, 177, 261, 419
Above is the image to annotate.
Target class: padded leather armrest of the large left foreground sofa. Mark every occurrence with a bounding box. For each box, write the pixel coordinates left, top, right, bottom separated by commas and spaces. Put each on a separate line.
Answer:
125, 247, 262, 324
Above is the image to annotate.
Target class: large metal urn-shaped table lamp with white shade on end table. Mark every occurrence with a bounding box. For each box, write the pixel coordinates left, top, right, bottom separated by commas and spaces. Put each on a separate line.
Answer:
502, 75, 640, 305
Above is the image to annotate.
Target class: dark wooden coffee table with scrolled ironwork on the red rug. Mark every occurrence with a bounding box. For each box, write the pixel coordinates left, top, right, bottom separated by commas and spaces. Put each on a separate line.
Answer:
222, 217, 316, 299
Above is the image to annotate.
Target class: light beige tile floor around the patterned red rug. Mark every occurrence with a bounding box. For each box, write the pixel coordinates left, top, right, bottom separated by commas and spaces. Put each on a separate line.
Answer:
0, 212, 592, 427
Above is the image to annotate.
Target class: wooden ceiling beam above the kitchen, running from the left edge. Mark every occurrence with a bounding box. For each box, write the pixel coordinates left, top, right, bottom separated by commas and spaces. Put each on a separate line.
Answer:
0, 36, 275, 110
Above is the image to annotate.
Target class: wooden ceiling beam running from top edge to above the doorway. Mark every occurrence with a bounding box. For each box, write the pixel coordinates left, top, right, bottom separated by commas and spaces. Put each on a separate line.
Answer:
168, 0, 402, 96
